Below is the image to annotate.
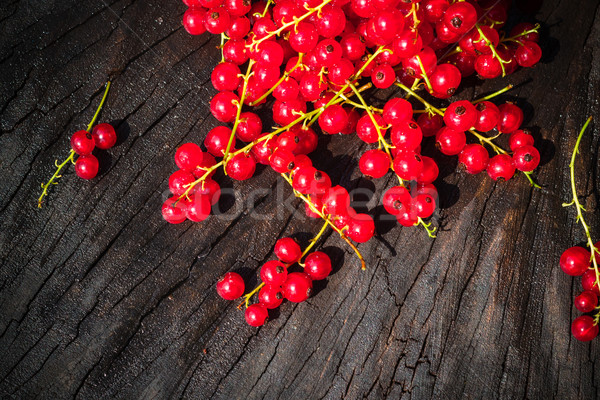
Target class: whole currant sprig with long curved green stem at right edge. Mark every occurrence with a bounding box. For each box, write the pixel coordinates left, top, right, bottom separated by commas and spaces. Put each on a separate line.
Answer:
560, 117, 600, 342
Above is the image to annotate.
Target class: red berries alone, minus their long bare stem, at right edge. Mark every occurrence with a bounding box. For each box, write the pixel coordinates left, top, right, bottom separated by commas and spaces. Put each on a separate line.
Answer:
560, 242, 600, 342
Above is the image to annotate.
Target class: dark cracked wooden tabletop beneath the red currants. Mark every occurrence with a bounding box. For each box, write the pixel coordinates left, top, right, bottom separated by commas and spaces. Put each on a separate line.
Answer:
0, 0, 600, 399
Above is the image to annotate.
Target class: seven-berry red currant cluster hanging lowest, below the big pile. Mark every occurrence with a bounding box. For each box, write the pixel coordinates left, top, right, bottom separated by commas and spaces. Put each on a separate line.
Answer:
217, 237, 332, 326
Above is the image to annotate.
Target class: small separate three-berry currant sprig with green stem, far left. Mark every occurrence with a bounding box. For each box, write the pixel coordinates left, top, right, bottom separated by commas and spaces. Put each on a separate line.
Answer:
38, 82, 117, 208
